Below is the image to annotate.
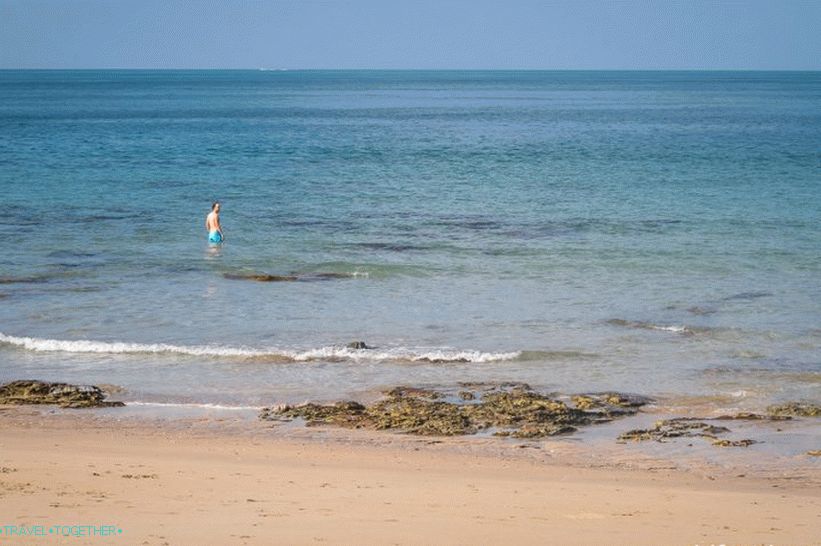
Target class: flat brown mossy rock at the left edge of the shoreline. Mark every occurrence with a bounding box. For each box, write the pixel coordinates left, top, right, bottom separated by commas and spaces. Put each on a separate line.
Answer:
0, 380, 125, 408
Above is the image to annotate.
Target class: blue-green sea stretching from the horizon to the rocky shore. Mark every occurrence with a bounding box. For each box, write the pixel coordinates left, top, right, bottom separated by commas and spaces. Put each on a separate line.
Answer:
0, 70, 821, 413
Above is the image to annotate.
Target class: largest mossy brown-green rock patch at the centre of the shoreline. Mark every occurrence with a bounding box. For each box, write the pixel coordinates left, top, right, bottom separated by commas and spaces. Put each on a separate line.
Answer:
260, 383, 652, 438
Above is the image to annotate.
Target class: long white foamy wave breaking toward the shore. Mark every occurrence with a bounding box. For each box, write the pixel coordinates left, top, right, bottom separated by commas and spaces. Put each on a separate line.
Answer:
0, 333, 521, 363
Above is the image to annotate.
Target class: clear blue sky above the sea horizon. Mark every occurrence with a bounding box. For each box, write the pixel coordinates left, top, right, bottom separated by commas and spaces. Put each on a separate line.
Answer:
0, 0, 821, 70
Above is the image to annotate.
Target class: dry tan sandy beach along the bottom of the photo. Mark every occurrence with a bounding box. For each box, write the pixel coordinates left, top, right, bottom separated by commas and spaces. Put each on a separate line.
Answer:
0, 407, 821, 545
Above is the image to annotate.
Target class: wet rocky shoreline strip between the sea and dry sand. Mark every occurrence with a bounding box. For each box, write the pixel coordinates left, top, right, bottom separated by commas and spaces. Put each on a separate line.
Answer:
0, 380, 821, 480
